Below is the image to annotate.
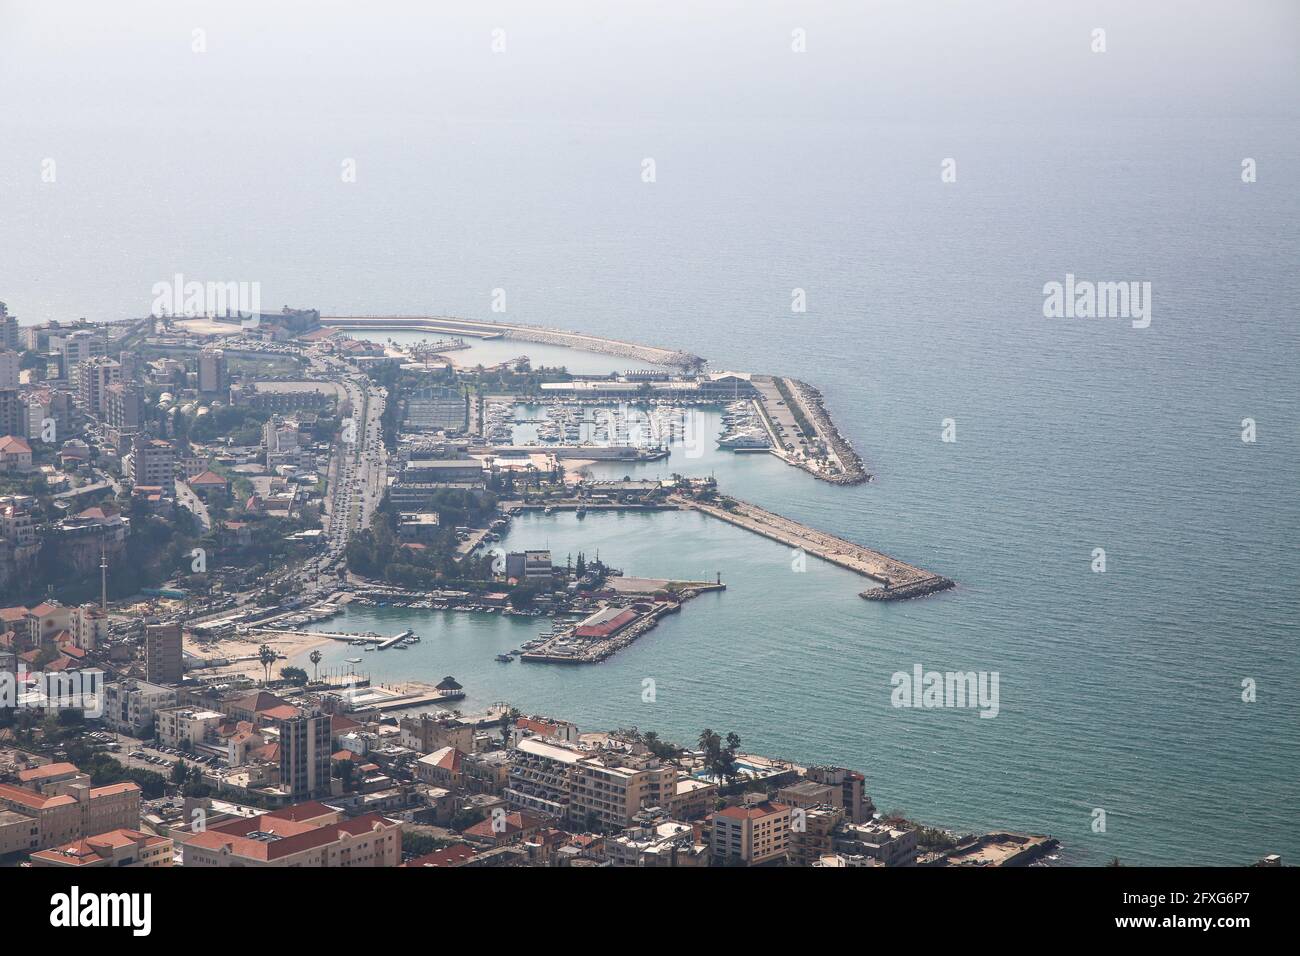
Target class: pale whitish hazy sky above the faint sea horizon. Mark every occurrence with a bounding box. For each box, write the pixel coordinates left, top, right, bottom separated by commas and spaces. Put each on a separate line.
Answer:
0, 0, 1300, 136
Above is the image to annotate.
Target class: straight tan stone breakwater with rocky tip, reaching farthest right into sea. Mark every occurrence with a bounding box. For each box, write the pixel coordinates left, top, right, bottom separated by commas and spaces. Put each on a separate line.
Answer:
673, 497, 956, 601
